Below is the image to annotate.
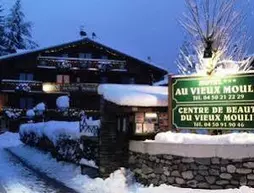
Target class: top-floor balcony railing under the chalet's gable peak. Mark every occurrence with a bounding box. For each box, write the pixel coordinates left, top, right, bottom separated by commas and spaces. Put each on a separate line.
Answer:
37, 56, 126, 71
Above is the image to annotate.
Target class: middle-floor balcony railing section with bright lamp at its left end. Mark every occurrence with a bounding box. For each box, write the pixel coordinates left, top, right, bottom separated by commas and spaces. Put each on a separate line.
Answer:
42, 83, 98, 93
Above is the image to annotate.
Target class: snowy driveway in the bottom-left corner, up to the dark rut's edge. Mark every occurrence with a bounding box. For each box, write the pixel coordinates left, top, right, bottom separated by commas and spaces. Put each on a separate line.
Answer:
0, 149, 78, 193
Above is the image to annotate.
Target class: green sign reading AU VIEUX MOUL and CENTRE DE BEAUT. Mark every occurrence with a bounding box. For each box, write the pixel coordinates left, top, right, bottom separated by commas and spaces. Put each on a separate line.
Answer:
172, 74, 254, 129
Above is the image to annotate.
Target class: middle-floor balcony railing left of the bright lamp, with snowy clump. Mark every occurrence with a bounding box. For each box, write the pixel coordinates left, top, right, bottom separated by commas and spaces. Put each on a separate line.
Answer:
1, 79, 42, 92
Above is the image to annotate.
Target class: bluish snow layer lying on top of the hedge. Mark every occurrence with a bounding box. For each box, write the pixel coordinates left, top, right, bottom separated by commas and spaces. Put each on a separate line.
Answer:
19, 121, 80, 144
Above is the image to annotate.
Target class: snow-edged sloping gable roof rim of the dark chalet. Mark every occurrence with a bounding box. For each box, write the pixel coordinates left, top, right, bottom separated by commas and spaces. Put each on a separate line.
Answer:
0, 38, 168, 73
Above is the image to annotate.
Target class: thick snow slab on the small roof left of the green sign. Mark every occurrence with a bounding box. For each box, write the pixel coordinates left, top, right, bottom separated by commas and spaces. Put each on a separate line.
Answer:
98, 84, 168, 107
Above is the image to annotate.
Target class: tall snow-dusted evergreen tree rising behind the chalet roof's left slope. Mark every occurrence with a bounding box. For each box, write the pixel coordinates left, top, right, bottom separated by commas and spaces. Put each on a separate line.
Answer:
6, 0, 37, 53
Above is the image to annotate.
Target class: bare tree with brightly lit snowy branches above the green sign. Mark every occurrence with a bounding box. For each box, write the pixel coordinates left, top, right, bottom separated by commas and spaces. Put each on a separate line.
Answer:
176, 0, 250, 74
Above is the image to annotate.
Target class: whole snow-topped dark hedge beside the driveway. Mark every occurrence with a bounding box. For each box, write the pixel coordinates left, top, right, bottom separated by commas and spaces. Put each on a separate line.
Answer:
19, 120, 98, 165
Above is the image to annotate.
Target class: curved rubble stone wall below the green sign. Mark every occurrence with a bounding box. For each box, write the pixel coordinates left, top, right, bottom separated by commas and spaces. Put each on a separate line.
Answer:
129, 141, 254, 189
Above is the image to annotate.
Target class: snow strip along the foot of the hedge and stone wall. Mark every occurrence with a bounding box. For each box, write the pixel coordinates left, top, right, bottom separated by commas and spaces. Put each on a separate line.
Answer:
0, 133, 254, 193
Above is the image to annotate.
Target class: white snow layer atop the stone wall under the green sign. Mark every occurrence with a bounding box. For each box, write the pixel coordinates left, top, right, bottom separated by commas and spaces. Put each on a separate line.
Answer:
153, 131, 254, 145
